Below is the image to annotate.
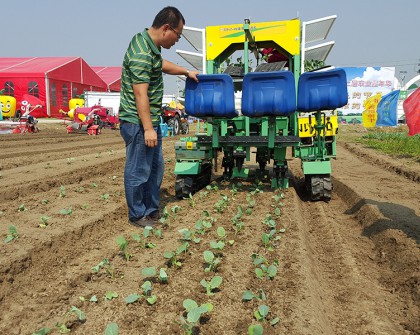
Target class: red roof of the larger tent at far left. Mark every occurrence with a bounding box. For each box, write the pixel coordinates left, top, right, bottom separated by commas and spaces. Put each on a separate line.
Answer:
0, 57, 107, 89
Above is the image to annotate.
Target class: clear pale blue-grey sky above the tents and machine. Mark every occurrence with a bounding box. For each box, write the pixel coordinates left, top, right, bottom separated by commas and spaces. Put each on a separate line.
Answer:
4, 0, 420, 93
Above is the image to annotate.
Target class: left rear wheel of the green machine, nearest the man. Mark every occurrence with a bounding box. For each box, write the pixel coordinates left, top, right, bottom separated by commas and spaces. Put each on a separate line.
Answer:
175, 163, 211, 199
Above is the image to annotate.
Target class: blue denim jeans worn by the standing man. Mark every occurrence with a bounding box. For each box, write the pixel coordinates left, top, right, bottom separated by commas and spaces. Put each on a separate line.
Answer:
120, 122, 164, 222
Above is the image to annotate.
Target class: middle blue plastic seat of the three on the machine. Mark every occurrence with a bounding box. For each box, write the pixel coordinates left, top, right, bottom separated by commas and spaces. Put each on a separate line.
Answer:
242, 71, 296, 117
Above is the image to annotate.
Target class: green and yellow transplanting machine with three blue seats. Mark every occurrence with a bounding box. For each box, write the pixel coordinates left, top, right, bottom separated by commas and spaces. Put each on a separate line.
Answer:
175, 19, 348, 201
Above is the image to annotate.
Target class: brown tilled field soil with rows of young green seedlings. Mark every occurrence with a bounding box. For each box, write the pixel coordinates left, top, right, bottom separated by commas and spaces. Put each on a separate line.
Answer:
0, 123, 420, 335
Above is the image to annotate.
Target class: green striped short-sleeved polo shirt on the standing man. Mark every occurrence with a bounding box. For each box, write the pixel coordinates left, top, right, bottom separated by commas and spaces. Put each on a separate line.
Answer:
119, 29, 163, 125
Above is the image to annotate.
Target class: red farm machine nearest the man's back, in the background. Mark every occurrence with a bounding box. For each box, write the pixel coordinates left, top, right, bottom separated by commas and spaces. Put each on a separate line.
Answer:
66, 105, 119, 135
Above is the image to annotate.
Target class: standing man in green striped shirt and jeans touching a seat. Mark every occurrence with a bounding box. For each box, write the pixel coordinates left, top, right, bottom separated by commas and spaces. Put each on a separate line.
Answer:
119, 7, 198, 227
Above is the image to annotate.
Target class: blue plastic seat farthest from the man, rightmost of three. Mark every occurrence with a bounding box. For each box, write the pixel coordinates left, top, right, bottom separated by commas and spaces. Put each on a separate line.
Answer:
297, 69, 348, 112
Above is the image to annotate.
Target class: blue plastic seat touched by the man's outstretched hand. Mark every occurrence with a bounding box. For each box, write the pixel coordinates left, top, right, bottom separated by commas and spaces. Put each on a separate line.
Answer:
185, 74, 238, 118
